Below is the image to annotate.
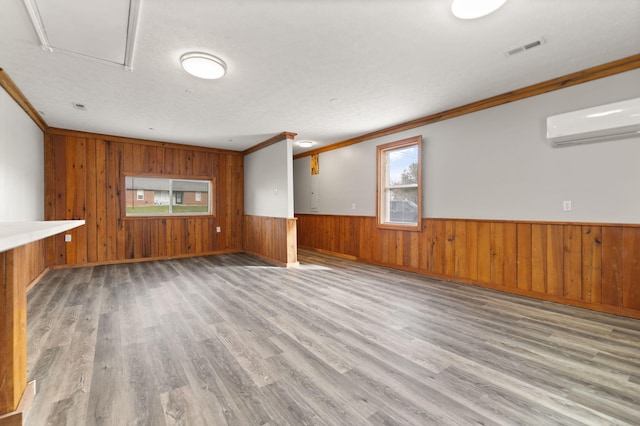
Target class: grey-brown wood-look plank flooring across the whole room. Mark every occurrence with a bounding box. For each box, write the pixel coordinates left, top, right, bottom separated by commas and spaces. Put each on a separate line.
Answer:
27, 251, 640, 426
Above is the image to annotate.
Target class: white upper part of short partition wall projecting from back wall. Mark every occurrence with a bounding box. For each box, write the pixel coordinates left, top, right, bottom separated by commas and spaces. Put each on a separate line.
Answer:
244, 139, 293, 218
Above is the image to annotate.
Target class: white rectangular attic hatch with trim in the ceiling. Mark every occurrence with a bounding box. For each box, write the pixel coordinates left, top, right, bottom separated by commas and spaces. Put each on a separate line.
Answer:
23, 0, 140, 69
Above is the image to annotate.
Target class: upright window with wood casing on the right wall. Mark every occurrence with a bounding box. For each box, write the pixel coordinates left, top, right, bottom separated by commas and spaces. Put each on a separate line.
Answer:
377, 136, 422, 230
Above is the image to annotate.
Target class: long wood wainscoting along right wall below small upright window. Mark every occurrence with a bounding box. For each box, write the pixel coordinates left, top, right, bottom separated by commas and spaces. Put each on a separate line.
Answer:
297, 214, 640, 319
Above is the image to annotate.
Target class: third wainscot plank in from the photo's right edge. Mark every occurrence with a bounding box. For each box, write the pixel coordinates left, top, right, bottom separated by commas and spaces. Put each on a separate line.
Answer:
582, 225, 602, 303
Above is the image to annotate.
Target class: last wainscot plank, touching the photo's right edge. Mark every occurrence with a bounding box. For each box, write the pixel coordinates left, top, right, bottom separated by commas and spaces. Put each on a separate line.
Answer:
622, 228, 640, 310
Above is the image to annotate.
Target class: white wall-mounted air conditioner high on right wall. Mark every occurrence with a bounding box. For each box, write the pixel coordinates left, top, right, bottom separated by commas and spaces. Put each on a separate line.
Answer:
547, 98, 640, 146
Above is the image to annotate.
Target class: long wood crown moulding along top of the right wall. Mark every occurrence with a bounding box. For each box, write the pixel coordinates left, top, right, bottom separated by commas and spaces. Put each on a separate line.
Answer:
293, 54, 640, 160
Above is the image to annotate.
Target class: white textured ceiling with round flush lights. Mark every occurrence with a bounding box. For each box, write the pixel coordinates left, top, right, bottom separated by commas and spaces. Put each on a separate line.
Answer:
0, 0, 640, 152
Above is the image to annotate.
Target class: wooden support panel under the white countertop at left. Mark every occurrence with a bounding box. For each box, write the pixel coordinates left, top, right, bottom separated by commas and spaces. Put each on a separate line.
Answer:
0, 240, 47, 425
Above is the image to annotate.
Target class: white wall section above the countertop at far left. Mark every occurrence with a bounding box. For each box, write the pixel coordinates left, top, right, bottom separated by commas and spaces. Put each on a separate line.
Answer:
0, 89, 44, 222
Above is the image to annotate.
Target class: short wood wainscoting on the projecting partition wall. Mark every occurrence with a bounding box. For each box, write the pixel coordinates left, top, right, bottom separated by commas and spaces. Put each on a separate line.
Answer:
243, 215, 298, 266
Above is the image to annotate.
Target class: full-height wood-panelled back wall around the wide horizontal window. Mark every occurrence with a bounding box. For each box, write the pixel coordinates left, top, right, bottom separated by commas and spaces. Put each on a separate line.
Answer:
45, 129, 244, 266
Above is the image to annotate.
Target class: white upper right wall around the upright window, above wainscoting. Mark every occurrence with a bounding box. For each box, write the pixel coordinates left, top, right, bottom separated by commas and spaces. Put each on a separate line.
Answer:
294, 70, 640, 223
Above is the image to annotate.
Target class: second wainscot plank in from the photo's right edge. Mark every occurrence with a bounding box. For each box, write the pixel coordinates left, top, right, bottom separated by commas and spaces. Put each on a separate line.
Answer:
601, 226, 624, 306
